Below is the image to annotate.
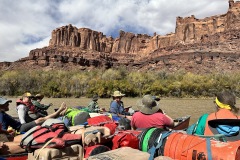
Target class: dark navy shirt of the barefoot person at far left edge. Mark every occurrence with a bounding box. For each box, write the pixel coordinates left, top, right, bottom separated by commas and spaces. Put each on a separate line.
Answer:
0, 112, 21, 130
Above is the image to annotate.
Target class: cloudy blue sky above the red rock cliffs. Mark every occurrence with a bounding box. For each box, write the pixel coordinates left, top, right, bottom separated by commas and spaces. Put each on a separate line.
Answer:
0, 0, 228, 62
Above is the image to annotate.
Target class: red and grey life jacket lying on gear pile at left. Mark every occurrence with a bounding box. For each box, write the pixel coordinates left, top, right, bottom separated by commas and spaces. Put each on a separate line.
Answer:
20, 118, 82, 152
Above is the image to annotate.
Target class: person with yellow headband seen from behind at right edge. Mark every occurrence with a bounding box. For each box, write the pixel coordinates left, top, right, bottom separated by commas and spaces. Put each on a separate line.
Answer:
190, 91, 240, 137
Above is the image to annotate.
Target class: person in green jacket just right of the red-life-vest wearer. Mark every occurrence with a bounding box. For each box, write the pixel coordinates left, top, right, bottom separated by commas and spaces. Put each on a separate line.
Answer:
32, 94, 53, 117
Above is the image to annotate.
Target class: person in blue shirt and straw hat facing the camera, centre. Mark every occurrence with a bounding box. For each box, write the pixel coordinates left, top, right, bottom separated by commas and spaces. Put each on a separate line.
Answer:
110, 91, 130, 117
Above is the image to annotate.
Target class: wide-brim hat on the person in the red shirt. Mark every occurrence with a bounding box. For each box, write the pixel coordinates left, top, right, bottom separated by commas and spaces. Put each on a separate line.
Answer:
137, 95, 160, 114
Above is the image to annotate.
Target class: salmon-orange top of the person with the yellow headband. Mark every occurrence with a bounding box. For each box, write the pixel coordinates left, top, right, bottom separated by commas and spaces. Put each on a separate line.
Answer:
204, 109, 239, 135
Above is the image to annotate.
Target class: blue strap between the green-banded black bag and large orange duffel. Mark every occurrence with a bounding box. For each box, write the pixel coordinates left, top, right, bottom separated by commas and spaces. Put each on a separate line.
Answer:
148, 131, 172, 160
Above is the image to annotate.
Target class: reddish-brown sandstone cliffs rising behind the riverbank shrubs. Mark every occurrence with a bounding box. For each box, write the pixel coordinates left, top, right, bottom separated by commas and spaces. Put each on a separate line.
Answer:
0, 0, 240, 73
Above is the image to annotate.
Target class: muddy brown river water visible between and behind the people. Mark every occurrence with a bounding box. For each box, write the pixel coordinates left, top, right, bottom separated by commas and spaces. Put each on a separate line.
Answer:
7, 97, 239, 124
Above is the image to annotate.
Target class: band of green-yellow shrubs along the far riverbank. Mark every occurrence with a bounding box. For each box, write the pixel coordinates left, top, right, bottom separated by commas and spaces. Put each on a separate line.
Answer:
0, 67, 240, 97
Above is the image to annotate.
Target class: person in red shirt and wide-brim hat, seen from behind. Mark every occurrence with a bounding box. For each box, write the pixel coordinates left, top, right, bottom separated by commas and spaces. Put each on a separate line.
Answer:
131, 95, 174, 130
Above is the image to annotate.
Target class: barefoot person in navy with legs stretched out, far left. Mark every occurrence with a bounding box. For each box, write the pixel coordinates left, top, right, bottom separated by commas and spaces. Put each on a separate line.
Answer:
0, 97, 66, 132
